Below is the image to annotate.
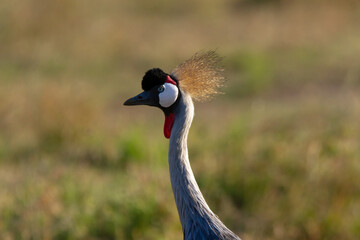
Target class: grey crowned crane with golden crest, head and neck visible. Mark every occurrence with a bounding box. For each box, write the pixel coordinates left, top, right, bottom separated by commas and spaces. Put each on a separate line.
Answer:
124, 50, 240, 240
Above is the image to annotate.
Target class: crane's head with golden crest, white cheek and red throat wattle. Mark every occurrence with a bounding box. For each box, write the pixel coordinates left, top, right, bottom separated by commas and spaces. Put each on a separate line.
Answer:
124, 51, 224, 138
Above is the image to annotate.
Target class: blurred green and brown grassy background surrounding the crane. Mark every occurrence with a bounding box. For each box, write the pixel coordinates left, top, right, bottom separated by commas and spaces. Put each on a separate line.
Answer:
0, 0, 360, 240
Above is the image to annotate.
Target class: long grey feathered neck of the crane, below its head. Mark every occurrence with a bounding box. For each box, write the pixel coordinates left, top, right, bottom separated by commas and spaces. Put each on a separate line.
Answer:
169, 92, 240, 240
